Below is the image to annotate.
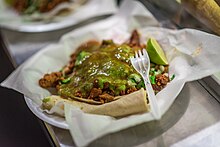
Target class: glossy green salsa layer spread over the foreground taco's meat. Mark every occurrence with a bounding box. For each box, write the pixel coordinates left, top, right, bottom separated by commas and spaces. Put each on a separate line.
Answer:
59, 41, 142, 98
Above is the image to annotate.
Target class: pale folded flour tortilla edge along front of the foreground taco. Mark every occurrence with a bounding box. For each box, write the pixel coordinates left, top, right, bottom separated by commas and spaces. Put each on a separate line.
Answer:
42, 88, 150, 117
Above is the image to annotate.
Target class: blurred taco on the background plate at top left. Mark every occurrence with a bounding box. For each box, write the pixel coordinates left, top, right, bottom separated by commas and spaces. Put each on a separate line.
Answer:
5, 0, 86, 20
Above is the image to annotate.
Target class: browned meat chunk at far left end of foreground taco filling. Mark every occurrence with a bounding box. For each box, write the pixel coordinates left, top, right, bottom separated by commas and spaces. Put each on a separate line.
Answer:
39, 72, 62, 88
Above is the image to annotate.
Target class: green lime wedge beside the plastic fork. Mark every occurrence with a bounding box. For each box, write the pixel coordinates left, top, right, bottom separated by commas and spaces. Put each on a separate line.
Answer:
147, 38, 168, 65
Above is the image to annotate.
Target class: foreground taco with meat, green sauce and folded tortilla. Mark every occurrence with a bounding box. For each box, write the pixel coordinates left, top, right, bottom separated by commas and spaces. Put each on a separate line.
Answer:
39, 30, 169, 117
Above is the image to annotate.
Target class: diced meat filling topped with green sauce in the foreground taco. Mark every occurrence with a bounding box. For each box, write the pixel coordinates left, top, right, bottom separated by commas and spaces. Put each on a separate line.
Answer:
39, 30, 172, 104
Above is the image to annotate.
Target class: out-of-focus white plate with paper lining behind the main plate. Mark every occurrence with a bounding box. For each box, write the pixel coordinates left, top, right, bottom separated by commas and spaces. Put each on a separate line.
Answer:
0, 0, 117, 32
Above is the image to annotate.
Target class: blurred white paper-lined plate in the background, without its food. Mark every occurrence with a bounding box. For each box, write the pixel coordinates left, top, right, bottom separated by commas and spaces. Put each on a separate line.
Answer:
0, 0, 116, 32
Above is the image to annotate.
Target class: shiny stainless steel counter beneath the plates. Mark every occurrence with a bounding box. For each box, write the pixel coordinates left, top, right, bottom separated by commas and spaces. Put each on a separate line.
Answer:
2, 0, 220, 147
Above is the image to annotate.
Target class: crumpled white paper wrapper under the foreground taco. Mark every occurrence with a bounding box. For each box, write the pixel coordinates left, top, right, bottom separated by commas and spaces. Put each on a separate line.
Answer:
1, 1, 220, 146
